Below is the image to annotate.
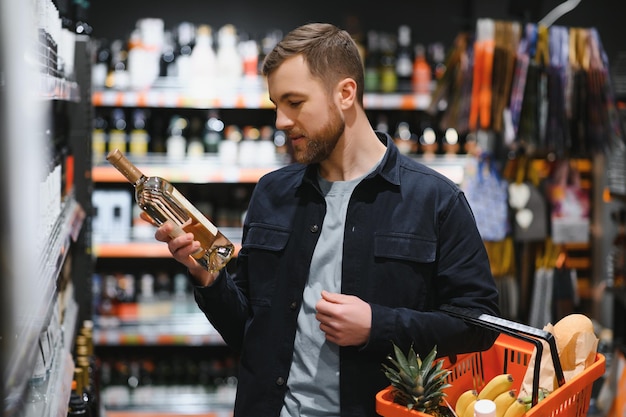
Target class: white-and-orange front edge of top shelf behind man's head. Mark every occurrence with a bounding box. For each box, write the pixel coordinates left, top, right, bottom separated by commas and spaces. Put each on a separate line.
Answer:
92, 88, 430, 110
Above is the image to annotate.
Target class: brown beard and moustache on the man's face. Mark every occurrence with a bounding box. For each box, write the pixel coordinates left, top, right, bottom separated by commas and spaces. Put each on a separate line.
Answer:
289, 102, 346, 164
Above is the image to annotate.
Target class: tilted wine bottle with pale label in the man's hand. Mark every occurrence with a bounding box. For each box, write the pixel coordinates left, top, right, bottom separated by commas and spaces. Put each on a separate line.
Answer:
107, 149, 235, 272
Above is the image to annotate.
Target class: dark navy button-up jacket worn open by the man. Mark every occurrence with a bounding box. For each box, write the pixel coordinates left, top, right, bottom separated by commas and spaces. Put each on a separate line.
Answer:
195, 134, 499, 417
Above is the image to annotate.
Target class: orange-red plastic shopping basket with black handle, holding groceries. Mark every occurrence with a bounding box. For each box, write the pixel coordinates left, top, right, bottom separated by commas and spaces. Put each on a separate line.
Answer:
376, 307, 605, 417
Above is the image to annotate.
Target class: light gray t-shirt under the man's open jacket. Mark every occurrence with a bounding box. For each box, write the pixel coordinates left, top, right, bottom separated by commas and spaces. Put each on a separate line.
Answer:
280, 171, 364, 417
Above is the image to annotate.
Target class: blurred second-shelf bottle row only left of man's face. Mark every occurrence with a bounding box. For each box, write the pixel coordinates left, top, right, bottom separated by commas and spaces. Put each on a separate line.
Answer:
92, 108, 289, 167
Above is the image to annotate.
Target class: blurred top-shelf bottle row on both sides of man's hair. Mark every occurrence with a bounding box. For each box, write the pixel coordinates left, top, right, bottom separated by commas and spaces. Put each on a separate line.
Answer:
92, 18, 446, 93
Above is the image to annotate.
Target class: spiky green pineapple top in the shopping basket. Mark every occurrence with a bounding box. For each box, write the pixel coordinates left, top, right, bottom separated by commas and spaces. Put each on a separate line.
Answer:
382, 343, 451, 417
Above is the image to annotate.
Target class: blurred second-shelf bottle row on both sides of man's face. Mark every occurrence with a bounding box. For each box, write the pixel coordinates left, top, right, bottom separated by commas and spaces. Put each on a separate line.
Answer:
92, 108, 466, 167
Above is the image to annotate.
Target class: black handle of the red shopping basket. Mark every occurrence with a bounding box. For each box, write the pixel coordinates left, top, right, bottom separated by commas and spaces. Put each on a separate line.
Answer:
440, 305, 565, 406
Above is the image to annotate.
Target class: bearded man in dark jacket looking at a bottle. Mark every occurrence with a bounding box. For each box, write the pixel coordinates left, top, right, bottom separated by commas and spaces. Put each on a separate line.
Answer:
155, 24, 498, 417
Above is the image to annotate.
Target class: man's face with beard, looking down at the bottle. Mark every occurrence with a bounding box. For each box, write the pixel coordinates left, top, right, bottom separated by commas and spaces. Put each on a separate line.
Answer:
268, 55, 345, 164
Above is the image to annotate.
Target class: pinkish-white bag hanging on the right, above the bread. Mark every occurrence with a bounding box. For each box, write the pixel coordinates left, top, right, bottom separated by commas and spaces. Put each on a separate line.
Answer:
548, 160, 591, 243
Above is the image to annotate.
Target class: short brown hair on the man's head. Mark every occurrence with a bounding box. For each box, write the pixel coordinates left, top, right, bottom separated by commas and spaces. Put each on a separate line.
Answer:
263, 23, 364, 107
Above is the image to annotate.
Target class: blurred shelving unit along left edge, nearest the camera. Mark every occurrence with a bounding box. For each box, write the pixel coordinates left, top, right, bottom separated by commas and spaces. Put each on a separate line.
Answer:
0, 2, 92, 417
